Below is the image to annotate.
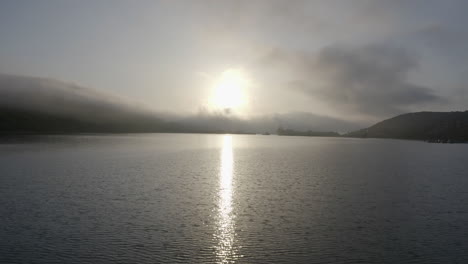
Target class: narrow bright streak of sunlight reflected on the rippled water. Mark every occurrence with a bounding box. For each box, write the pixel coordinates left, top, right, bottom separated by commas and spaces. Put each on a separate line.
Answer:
215, 135, 237, 263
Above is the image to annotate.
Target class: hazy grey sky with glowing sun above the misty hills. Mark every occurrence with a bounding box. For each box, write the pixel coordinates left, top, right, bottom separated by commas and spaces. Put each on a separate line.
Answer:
0, 0, 468, 123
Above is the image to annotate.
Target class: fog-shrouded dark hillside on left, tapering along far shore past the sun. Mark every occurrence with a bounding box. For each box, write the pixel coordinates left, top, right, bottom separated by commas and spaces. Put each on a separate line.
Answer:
0, 74, 367, 133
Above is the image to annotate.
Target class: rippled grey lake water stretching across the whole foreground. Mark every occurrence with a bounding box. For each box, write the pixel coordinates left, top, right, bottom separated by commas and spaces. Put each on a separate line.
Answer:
0, 134, 468, 263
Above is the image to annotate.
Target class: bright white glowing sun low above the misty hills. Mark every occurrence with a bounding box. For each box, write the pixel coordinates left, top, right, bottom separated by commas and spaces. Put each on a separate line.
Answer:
211, 69, 248, 110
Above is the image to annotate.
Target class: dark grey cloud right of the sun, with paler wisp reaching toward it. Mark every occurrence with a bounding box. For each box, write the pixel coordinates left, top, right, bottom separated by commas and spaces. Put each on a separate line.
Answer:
261, 45, 444, 117
